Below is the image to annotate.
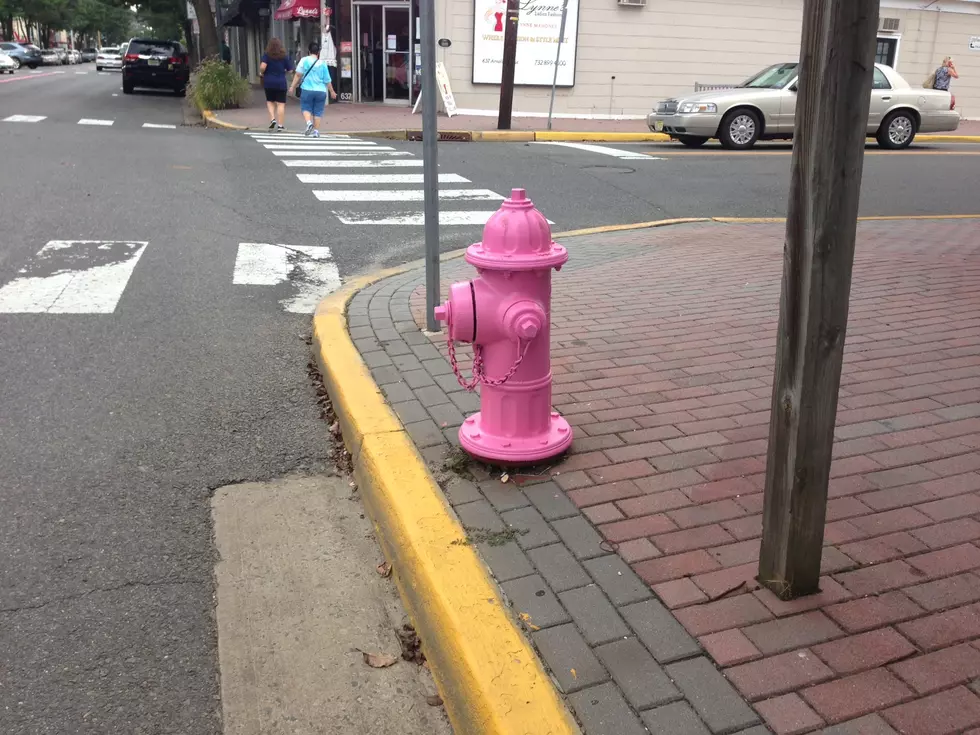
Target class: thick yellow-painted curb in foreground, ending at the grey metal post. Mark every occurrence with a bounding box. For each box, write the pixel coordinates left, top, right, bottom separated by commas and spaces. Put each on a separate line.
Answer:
313, 266, 579, 735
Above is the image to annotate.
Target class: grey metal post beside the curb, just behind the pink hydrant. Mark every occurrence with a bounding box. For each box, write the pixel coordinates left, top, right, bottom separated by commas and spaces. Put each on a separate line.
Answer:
419, 0, 441, 332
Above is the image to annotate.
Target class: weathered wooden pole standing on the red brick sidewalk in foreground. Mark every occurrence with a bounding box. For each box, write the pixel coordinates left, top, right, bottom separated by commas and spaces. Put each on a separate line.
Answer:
759, 0, 879, 599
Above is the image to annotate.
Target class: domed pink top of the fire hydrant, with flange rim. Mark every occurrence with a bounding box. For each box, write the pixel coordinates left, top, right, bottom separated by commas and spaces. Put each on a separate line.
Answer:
466, 189, 568, 270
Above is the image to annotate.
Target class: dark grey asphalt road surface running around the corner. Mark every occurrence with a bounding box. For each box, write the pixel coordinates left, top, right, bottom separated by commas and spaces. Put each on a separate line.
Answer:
0, 64, 980, 735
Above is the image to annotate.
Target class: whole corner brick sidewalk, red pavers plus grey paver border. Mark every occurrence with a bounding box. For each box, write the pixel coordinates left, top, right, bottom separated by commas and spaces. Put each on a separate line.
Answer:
349, 220, 980, 735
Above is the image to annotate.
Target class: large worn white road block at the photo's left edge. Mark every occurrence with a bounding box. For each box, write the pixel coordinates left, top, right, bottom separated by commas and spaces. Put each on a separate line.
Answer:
0, 240, 147, 314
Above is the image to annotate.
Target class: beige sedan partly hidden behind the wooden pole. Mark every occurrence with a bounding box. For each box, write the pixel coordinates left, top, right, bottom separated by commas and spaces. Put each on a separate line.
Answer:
647, 62, 960, 149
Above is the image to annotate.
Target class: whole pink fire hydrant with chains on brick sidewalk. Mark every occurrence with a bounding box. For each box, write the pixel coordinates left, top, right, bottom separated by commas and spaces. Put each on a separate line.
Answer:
435, 189, 572, 464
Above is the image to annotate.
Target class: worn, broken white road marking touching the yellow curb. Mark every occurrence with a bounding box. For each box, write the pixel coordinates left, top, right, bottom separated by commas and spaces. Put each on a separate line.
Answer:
232, 242, 341, 314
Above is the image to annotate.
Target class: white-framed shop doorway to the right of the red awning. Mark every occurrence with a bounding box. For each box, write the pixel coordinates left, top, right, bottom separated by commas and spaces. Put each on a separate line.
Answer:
353, 3, 415, 105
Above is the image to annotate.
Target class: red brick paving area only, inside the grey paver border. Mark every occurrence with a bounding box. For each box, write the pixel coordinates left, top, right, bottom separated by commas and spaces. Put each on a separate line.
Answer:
416, 220, 980, 735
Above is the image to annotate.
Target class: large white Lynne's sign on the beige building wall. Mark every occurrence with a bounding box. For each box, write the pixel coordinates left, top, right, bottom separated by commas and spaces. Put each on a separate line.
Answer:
473, 0, 579, 87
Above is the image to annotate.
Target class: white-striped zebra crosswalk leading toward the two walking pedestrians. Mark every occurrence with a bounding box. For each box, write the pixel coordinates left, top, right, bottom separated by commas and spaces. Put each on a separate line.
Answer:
242, 132, 553, 230
